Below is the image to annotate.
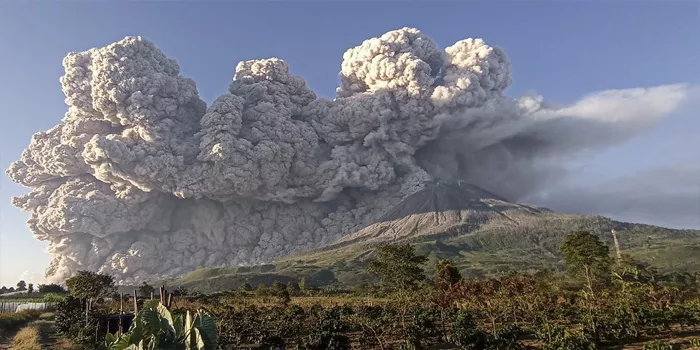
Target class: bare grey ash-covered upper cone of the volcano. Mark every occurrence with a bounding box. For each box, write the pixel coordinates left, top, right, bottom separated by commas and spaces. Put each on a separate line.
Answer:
337, 181, 549, 243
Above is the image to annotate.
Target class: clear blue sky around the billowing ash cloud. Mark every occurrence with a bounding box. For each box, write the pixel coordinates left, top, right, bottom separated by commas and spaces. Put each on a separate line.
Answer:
0, 1, 700, 285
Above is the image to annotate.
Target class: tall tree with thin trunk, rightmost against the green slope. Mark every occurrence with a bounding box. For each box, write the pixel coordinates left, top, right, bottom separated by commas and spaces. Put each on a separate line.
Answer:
560, 231, 613, 295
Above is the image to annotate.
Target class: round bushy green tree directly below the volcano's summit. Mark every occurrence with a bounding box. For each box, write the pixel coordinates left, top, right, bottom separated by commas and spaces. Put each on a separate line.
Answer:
367, 244, 428, 290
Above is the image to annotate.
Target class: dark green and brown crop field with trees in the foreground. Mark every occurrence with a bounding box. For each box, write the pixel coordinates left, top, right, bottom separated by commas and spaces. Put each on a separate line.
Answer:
4, 232, 700, 350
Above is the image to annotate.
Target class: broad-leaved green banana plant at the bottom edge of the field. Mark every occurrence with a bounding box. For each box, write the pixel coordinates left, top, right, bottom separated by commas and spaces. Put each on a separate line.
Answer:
103, 300, 217, 350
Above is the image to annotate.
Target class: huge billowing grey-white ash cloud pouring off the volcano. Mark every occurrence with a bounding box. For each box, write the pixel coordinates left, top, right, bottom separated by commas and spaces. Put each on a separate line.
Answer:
7, 28, 688, 283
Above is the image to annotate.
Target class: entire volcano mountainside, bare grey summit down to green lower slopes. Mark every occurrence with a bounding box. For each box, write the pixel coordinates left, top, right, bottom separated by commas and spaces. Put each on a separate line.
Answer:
167, 183, 700, 291
